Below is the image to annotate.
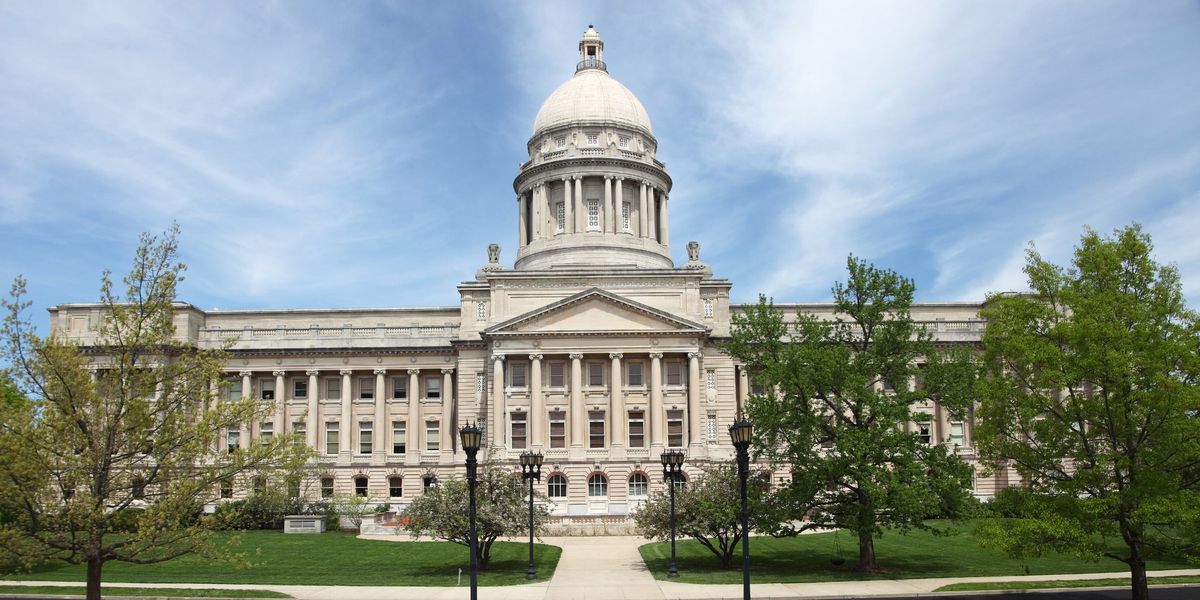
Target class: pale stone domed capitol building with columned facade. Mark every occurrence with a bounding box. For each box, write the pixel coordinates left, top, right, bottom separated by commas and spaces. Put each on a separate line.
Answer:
50, 26, 1007, 524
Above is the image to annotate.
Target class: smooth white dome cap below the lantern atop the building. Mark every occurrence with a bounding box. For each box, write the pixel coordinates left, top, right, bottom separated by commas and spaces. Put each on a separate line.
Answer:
533, 68, 654, 137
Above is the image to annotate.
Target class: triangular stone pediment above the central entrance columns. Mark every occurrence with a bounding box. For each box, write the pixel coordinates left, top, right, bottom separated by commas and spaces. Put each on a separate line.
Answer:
485, 288, 707, 336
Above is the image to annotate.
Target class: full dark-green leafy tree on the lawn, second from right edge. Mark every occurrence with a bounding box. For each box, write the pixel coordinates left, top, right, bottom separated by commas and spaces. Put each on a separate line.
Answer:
726, 256, 974, 571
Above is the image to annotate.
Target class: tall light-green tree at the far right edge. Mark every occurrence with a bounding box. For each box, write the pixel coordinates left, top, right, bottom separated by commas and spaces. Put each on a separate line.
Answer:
977, 226, 1200, 599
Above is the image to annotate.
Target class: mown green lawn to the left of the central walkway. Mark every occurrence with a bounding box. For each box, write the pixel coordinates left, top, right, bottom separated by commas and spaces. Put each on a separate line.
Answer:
5, 532, 562, 586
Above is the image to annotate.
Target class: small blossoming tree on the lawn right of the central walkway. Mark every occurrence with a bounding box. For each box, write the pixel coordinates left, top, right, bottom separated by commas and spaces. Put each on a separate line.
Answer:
634, 463, 778, 569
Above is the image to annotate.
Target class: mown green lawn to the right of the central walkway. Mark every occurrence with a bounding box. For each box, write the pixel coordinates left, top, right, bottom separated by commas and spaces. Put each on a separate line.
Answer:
640, 522, 1193, 583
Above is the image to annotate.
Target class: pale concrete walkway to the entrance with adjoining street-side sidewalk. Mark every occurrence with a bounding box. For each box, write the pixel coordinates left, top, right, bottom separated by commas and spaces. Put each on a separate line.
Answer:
0, 535, 1200, 600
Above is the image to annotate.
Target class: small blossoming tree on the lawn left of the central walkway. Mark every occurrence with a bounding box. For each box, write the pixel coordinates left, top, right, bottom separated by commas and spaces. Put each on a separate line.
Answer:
401, 464, 548, 569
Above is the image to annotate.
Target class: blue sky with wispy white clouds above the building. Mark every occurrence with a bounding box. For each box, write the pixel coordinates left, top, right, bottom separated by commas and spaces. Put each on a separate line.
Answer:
0, 0, 1200, 323
